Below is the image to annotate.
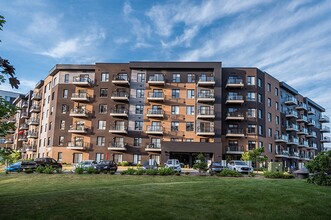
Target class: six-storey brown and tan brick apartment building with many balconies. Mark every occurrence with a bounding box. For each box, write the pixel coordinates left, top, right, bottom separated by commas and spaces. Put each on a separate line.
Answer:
3, 62, 330, 167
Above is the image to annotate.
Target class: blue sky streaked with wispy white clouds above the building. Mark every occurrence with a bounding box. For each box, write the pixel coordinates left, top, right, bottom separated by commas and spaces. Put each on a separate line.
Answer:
0, 0, 331, 113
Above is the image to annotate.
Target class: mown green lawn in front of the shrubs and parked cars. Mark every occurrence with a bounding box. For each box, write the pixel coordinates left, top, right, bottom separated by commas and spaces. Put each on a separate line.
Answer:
0, 173, 331, 220
